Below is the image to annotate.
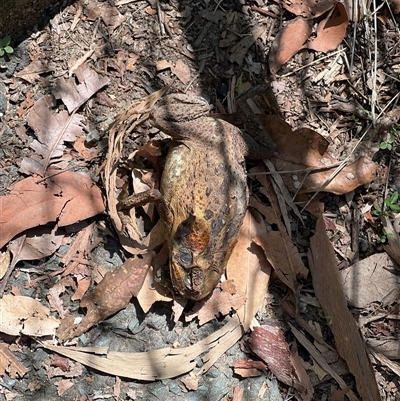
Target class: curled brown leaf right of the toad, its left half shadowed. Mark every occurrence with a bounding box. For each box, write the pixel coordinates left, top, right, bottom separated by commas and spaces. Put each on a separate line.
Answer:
258, 115, 378, 195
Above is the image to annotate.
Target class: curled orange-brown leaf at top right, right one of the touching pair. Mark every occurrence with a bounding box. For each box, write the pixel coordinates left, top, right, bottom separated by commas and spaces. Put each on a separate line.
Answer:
304, 3, 349, 53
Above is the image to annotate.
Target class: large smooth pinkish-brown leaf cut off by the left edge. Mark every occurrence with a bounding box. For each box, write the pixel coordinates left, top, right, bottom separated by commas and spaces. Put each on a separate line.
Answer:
0, 170, 104, 248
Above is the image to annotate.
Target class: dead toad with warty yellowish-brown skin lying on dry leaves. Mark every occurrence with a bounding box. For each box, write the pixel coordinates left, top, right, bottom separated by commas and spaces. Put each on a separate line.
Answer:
119, 94, 271, 300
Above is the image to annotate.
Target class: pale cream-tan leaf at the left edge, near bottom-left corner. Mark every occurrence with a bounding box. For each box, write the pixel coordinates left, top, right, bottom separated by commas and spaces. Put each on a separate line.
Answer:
0, 295, 60, 337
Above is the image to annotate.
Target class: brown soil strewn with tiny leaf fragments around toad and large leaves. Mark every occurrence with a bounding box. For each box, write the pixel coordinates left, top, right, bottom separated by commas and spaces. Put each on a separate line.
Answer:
0, 0, 400, 401
